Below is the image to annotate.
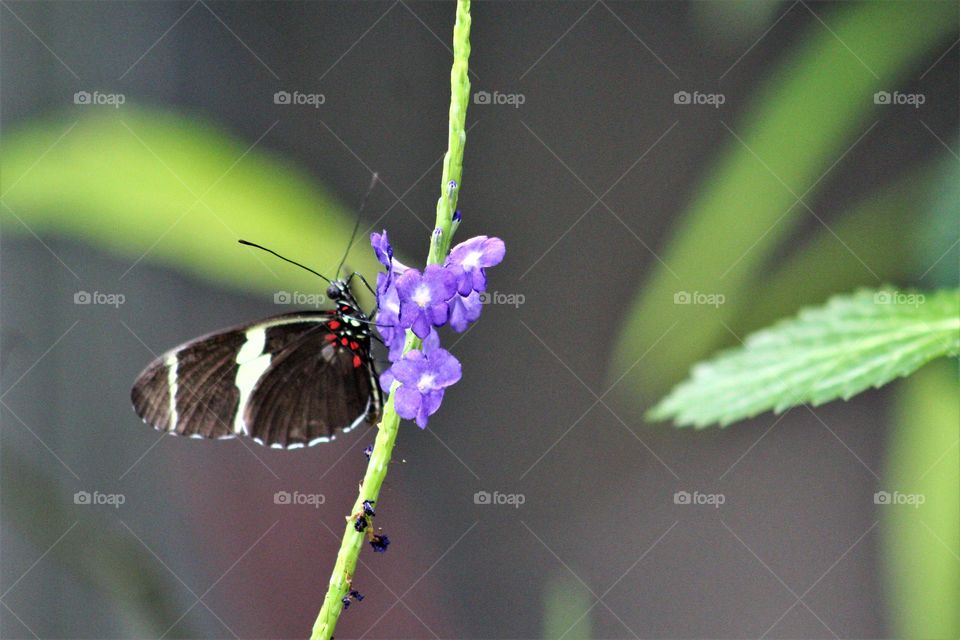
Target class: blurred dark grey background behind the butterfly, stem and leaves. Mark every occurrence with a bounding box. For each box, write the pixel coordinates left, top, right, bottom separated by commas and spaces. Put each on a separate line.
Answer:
0, 1, 958, 638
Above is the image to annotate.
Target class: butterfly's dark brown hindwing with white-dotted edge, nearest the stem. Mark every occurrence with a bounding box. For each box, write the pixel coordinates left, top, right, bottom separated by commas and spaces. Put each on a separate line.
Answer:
244, 327, 383, 448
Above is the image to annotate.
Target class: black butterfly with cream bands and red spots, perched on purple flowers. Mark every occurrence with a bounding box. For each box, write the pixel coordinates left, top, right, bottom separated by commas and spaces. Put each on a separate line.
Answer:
131, 239, 383, 449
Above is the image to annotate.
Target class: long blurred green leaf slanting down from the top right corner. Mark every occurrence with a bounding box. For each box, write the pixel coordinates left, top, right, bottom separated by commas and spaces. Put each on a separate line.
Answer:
610, 2, 956, 403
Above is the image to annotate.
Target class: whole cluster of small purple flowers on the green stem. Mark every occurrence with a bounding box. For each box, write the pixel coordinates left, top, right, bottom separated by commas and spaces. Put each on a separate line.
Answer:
370, 229, 506, 429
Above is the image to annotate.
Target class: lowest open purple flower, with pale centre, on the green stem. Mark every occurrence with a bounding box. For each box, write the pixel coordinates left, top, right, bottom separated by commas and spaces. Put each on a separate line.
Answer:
390, 347, 461, 429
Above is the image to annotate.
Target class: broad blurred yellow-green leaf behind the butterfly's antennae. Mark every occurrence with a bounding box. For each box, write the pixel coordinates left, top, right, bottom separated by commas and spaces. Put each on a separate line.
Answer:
0, 106, 377, 300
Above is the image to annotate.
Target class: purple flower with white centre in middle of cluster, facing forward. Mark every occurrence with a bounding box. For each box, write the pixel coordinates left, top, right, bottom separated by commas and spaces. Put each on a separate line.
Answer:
396, 264, 457, 338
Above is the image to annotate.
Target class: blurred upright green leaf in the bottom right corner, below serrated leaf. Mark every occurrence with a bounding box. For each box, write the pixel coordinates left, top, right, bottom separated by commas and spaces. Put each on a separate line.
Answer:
878, 362, 960, 639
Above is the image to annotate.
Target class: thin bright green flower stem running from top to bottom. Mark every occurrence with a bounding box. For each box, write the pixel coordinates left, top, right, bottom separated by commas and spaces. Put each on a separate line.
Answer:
310, 0, 470, 640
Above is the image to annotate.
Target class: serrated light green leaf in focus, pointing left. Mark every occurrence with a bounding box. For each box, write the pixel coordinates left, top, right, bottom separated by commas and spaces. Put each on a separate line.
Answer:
650, 289, 960, 427
